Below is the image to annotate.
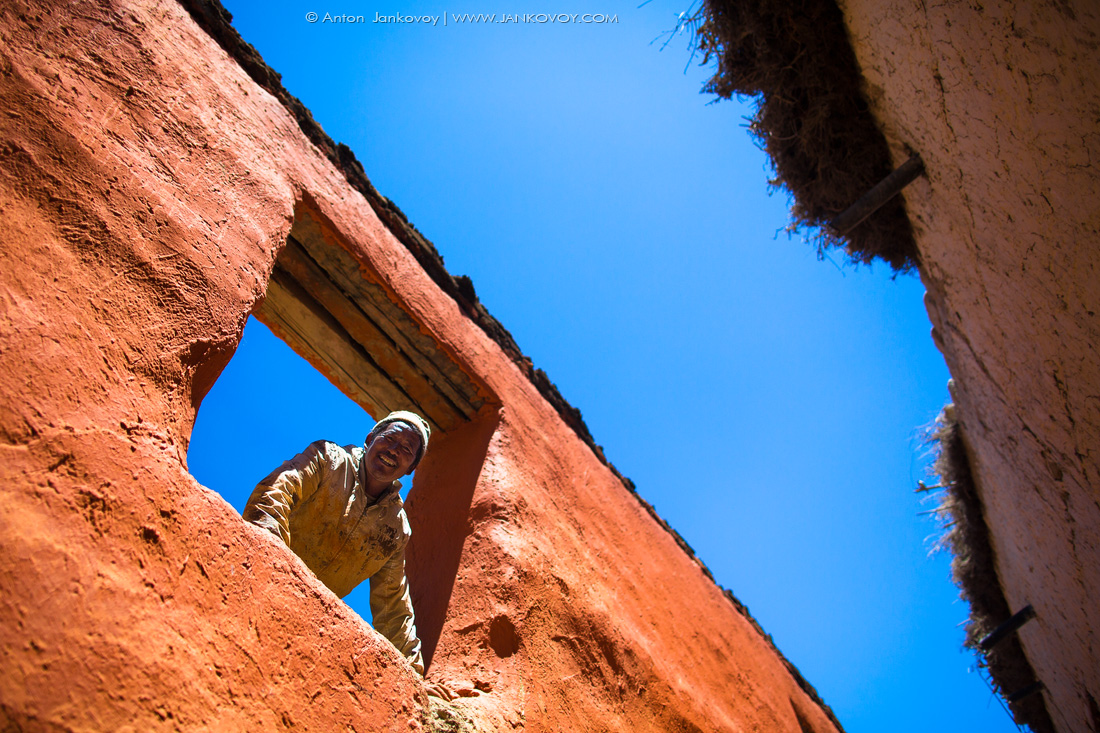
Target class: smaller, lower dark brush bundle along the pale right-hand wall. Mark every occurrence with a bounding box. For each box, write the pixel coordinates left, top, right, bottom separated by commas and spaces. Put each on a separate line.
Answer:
922, 405, 1054, 733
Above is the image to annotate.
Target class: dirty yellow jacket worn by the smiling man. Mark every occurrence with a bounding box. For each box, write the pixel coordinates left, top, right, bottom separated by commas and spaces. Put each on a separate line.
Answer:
244, 440, 424, 675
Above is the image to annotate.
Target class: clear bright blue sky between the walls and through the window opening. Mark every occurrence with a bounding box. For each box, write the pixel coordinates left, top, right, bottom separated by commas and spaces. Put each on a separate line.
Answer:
188, 0, 1015, 733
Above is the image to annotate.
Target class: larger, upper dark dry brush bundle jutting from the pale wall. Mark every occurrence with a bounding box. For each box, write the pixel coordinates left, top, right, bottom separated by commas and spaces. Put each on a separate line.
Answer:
694, 0, 917, 272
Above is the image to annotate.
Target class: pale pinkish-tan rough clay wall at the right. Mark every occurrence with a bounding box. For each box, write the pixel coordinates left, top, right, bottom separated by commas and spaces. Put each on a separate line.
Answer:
842, 0, 1100, 733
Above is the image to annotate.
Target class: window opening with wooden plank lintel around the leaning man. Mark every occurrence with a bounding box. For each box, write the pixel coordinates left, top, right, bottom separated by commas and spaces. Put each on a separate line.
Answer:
188, 206, 498, 664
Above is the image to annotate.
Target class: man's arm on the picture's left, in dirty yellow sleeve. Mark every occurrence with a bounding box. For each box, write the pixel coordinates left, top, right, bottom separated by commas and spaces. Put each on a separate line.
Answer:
243, 440, 327, 547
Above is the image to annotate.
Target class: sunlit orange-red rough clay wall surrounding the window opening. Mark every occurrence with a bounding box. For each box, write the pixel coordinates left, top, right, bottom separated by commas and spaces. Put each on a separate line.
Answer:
0, 0, 838, 733
